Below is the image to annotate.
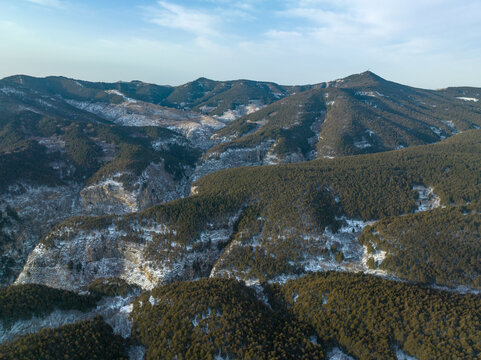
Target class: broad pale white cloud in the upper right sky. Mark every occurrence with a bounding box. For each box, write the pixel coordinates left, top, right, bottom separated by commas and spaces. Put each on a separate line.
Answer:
270, 0, 481, 55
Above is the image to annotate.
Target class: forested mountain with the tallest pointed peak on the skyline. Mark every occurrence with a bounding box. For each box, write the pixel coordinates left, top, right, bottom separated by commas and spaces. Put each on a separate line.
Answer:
212, 72, 481, 162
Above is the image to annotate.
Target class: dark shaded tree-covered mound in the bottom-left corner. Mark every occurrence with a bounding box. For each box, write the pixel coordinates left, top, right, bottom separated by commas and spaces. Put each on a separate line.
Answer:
0, 317, 129, 360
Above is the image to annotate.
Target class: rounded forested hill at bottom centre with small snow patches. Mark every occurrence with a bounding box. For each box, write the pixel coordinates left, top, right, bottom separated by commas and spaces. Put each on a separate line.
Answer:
132, 279, 324, 359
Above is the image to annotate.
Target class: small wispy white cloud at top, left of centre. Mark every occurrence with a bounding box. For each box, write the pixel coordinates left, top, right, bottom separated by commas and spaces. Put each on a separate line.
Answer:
147, 1, 219, 36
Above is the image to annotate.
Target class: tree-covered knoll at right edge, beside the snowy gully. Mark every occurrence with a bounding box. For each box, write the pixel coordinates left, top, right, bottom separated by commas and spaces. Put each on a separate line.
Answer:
359, 207, 481, 288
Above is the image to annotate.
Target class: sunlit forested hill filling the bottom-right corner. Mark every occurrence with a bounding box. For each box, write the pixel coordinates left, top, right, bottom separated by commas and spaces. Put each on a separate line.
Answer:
274, 272, 481, 360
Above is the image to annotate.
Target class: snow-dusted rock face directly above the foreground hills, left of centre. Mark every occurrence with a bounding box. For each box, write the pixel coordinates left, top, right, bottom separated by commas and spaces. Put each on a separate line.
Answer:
16, 215, 238, 291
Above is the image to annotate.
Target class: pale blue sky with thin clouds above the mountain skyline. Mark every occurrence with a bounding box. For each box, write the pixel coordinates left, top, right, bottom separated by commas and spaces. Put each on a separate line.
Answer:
0, 0, 481, 89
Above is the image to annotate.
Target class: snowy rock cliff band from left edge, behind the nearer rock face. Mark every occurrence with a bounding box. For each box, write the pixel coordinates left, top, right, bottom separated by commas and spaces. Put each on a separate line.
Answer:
0, 163, 190, 286
